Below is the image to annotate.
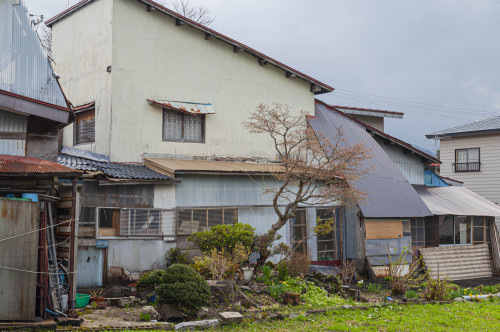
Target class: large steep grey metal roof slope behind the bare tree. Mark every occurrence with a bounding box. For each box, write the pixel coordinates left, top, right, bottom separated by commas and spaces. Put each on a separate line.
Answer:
309, 102, 432, 218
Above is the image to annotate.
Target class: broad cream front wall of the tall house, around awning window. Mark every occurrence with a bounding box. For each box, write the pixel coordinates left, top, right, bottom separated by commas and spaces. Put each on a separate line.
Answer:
107, 0, 314, 161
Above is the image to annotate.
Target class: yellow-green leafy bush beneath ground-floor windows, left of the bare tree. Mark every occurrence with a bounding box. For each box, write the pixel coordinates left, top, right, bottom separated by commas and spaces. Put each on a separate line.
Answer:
188, 223, 255, 253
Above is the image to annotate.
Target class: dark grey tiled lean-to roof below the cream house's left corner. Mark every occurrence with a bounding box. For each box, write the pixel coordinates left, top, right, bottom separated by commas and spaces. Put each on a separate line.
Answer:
57, 155, 172, 180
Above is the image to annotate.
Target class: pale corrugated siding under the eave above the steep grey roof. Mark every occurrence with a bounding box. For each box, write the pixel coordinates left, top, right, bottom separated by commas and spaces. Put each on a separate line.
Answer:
375, 137, 425, 184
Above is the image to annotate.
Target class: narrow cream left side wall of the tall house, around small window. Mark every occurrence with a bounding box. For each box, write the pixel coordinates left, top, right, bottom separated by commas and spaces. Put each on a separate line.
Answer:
52, 0, 113, 154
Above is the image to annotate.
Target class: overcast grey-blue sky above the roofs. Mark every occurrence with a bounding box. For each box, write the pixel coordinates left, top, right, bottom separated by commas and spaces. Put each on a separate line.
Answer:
25, 0, 500, 150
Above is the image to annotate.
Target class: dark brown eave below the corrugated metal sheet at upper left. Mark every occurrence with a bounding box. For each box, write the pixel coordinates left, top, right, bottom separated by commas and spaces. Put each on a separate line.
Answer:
0, 90, 74, 124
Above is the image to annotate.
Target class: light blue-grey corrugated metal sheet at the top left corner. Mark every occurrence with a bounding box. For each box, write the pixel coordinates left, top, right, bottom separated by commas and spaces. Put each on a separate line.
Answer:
0, 0, 66, 107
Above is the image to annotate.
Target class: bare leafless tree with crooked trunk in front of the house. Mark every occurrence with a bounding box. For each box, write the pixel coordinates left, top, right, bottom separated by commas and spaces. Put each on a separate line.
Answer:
243, 103, 371, 263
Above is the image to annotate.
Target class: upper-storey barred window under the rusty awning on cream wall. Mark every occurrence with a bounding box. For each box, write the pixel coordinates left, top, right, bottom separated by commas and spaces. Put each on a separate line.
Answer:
163, 109, 205, 143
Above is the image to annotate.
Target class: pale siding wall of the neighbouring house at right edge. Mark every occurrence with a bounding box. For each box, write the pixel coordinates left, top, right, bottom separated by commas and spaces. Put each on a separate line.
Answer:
440, 134, 500, 204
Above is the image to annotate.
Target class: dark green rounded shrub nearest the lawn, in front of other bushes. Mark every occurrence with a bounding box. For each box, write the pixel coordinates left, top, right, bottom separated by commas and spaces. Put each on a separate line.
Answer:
156, 264, 210, 313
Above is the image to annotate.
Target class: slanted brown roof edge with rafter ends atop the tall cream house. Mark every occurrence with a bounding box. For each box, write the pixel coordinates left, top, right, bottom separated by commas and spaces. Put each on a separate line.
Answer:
45, 0, 334, 94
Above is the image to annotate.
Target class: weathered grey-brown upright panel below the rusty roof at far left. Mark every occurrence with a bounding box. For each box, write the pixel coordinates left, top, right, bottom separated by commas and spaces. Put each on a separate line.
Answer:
0, 199, 40, 320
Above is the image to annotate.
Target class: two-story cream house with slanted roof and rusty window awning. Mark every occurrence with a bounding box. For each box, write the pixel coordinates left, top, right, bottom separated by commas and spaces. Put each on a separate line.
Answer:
47, 0, 337, 286
